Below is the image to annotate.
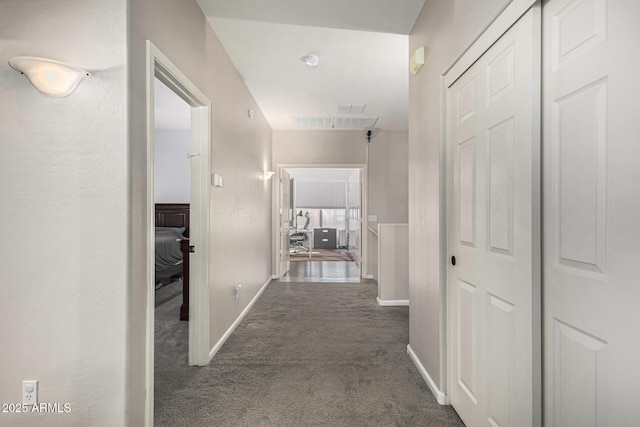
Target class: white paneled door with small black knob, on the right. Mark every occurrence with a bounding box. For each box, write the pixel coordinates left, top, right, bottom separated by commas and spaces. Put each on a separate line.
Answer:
447, 6, 541, 427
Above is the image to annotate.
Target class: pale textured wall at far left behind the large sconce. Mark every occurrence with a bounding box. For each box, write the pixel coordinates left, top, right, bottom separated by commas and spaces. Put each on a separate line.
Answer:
0, 0, 129, 426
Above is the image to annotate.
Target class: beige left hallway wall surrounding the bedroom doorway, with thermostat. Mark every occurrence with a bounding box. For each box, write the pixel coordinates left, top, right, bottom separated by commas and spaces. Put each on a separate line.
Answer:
129, 0, 272, 425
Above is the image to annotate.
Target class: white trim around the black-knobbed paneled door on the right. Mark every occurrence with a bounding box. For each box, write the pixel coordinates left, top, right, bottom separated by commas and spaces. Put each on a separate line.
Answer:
439, 0, 542, 426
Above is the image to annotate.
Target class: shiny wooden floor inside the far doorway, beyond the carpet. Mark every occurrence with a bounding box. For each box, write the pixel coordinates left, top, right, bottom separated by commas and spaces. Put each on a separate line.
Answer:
280, 261, 360, 283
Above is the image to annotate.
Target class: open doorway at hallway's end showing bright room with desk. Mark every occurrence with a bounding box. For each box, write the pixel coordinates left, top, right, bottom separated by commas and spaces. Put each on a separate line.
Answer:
276, 166, 364, 282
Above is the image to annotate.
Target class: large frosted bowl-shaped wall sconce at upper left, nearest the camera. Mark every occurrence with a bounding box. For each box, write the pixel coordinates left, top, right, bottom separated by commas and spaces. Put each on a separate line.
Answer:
9, 56, 90, 97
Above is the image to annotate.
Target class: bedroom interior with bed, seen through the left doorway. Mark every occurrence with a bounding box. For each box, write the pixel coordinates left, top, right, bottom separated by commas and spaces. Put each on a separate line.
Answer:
153, 77, 191, 409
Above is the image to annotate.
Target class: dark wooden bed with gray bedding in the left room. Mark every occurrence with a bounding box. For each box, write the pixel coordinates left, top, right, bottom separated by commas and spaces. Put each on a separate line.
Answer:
155, 203, 189, 320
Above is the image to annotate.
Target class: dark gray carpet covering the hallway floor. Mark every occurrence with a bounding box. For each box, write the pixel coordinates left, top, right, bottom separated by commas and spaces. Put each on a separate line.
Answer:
155, 282, 463, 427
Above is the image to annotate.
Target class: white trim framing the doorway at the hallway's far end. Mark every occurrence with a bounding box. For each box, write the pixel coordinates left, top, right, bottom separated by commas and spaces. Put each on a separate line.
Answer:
272, 163, 368, 278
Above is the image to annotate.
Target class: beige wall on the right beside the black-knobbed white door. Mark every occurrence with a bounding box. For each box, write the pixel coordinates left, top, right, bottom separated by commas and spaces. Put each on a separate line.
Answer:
409, 0, 510, 390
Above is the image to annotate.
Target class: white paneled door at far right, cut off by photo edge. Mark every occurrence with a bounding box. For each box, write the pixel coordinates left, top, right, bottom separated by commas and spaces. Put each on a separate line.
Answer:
543, 0, 640, 427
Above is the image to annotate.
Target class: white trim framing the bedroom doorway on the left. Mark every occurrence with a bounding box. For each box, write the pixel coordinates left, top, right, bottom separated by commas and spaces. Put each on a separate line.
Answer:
145, 40, 211, 426
